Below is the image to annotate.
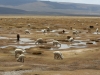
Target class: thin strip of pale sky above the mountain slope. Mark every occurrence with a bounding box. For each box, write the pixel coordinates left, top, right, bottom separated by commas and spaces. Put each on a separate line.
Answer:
40, 0, 100, 5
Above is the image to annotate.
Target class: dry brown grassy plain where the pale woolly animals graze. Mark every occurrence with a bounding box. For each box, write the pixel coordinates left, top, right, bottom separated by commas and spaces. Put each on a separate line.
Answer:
0, 16, 100, 75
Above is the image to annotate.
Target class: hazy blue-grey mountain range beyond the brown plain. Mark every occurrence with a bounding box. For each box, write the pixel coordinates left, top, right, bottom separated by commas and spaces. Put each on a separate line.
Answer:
0, 0, 100, 16
